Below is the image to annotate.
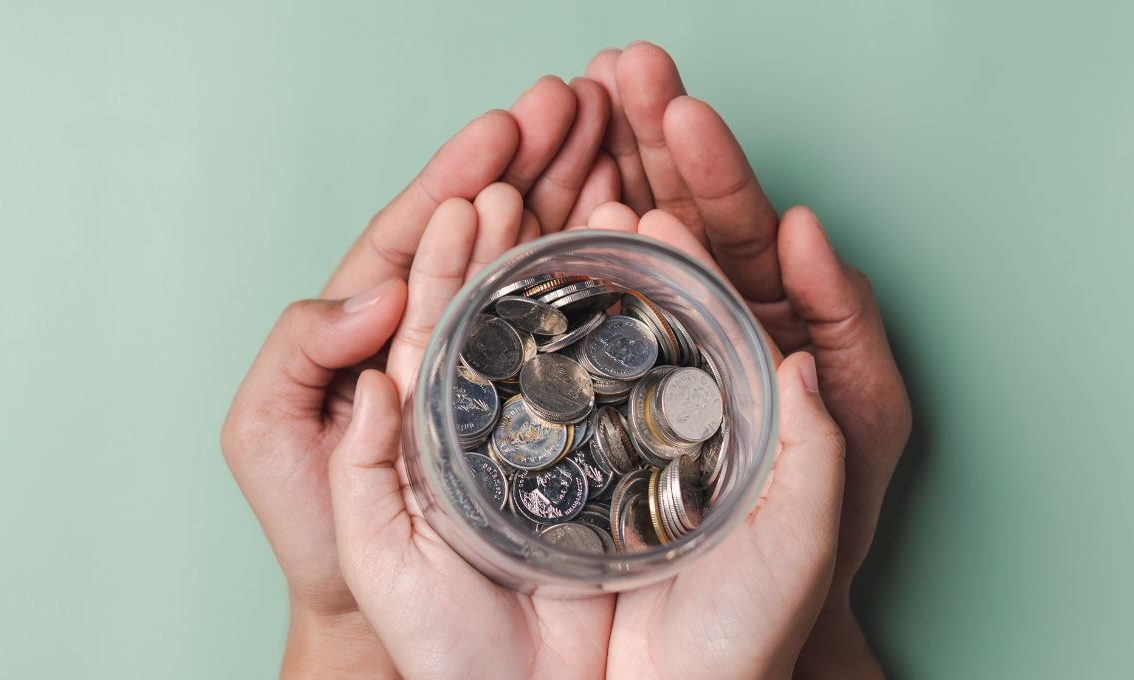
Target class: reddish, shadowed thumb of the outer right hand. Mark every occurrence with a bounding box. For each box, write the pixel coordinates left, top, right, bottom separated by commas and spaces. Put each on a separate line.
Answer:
779, 207, 911, 457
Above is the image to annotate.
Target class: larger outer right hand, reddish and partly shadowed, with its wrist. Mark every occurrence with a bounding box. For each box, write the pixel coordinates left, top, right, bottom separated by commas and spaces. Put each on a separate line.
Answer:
586, 43, 911, 675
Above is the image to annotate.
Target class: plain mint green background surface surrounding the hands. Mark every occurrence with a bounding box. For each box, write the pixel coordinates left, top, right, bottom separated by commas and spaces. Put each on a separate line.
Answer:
0, 0, 1134, 679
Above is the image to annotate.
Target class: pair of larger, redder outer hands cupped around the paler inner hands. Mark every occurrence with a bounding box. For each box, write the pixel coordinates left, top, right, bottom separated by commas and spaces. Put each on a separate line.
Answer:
222, 43, 909, 677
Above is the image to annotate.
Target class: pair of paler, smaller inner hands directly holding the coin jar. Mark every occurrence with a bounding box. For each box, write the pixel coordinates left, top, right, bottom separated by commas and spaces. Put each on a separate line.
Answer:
330, 187, 844, 678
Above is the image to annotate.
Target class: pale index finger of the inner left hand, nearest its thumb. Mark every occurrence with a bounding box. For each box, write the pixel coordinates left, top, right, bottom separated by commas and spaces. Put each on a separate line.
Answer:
387, 198, 476, 399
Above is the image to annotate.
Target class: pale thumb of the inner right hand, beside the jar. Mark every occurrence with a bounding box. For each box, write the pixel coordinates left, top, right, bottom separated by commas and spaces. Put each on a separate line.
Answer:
756, 351, 846, 571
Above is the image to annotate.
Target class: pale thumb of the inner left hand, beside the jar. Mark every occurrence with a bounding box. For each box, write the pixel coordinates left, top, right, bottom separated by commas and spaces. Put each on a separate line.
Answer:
329, 369, 411, 583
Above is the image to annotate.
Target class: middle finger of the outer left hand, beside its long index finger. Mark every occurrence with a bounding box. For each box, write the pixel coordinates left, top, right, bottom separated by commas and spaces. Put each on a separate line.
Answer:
503, 76, 576, 194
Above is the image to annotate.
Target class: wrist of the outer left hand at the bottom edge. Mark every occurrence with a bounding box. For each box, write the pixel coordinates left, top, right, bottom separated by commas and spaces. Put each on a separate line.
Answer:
280, 601, 399, 680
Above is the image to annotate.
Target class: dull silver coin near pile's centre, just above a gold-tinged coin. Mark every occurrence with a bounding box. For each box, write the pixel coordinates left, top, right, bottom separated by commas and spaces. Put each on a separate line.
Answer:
519, 354, 594, 423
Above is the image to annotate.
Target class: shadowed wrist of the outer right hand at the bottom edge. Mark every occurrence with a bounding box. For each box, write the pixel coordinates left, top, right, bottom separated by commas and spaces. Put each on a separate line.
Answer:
793, 594, 886, 680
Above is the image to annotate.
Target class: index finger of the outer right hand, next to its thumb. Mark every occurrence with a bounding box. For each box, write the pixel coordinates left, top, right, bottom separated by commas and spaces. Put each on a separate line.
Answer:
665, 96, 784, 303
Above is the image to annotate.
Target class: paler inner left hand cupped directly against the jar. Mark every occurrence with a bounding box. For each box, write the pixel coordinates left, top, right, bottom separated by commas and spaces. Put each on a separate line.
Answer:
330, 185, 613, 678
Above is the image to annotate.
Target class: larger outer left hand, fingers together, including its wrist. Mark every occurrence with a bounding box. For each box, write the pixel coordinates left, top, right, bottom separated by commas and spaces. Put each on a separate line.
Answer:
221, 77, 618, 677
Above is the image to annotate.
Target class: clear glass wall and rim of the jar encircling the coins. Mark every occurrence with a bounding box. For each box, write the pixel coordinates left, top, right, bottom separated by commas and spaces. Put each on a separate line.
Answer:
404, 229, 777, 596
